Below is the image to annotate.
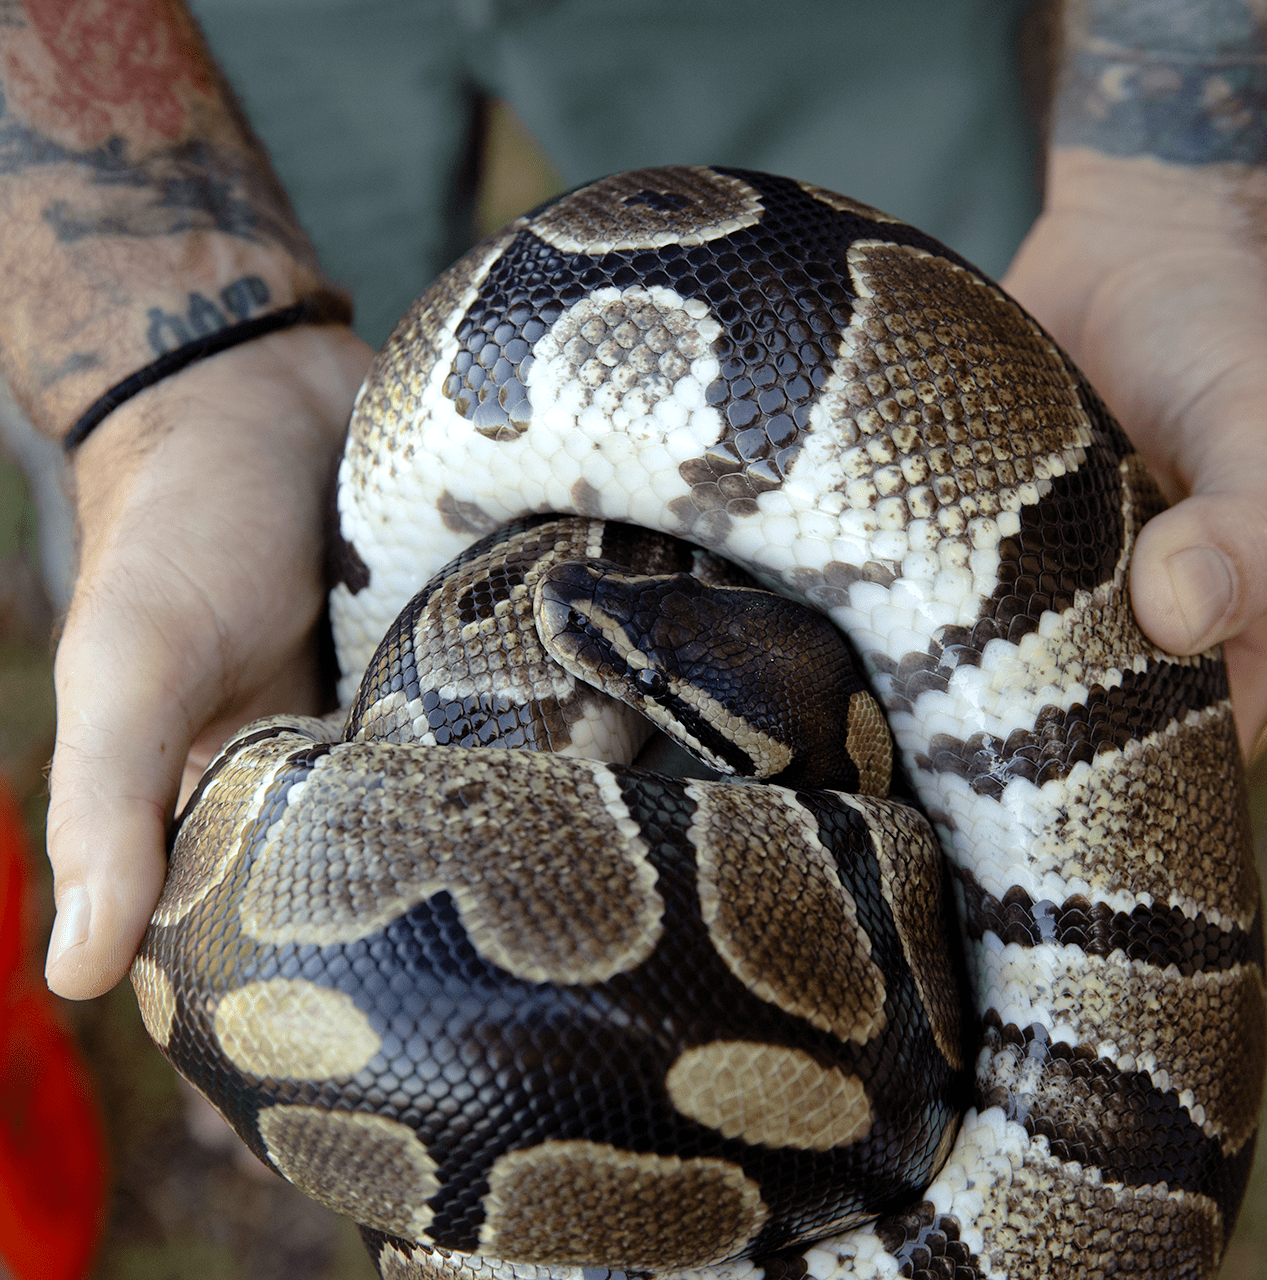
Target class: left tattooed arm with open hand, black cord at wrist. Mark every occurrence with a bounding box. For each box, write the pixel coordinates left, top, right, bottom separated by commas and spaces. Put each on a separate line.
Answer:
0, 0, 369, 996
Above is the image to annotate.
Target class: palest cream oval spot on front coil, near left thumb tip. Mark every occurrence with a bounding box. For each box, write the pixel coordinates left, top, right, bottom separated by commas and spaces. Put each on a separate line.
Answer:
212, 978, 381, 1080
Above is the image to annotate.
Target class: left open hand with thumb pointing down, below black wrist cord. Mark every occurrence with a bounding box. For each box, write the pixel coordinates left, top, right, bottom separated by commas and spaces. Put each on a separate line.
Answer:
46, 328, 371, 998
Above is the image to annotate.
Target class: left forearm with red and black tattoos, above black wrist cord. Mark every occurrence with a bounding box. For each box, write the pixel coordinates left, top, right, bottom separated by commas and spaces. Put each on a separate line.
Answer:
0, 0, 348, 438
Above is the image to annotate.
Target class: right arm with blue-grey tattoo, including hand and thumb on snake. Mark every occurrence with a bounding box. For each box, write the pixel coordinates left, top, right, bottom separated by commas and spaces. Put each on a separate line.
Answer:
1003, 0, 1267, 749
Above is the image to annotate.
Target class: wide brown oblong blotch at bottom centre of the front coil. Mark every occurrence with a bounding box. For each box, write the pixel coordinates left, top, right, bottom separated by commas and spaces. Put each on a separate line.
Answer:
480, 1140, 769, 1271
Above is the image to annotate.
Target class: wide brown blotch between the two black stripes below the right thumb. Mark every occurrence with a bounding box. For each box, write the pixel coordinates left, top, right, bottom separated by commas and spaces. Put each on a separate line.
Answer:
1033, 703, 1259, 928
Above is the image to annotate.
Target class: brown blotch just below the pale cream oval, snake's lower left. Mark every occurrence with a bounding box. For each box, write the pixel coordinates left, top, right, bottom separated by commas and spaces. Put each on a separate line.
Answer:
259, 1106, 440, 1239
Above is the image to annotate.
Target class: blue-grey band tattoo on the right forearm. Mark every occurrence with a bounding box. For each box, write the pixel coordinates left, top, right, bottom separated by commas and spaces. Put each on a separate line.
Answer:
1055, 0, 1267, 165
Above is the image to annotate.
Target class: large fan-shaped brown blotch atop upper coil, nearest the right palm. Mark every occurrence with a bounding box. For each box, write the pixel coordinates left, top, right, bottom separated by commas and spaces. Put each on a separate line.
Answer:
792, 241, 1090, 538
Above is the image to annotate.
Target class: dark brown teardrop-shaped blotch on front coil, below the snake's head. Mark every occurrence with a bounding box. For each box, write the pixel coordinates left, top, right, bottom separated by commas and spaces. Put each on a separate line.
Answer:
687, 783, 886, 1044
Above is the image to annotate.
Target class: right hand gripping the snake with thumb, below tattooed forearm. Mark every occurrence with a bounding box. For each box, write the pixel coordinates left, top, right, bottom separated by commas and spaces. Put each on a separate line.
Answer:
1002, 148, 1267, 754
